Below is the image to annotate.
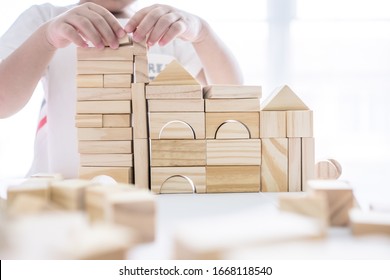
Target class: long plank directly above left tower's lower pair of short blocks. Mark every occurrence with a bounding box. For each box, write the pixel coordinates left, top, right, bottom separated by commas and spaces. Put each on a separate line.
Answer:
76, 100, 131, 114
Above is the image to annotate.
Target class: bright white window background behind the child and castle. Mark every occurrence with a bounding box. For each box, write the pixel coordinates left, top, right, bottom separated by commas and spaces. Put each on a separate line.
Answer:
0, 0, 390, 178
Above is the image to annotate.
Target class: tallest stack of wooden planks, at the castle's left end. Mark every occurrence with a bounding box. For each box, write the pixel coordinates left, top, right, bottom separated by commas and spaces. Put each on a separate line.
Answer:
76, 37, 148, 187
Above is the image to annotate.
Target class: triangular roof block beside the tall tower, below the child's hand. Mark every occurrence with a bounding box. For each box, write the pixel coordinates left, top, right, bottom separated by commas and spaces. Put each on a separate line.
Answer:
149, 60, 200, 86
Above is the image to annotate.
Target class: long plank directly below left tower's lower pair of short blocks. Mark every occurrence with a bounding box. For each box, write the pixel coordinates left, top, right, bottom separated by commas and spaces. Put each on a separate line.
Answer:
77, 127, 133, 141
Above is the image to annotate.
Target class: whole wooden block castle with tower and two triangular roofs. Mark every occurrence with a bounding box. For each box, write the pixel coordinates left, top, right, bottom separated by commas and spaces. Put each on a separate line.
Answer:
76, 38, 314, 193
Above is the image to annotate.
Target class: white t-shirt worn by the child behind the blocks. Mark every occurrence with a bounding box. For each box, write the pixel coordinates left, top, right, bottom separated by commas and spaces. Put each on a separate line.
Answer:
0, 4, 202, 178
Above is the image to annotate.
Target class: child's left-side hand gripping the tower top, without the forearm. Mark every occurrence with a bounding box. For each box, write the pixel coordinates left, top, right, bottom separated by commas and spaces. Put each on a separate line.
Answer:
46, 2, 126, 48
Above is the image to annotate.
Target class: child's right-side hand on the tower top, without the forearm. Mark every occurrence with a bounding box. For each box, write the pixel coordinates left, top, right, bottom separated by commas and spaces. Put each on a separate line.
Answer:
125, 4, 206, 46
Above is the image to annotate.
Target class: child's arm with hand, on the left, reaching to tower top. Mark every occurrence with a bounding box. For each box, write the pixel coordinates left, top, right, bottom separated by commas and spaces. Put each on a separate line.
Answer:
0, 3, 126, 118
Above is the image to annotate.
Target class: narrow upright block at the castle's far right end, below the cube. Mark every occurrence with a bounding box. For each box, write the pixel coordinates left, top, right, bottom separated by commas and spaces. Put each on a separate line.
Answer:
302, 138, 315, 191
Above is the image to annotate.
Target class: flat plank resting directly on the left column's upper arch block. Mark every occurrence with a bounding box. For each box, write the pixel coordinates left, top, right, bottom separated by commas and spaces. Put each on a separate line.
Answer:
148, 99, 204, 112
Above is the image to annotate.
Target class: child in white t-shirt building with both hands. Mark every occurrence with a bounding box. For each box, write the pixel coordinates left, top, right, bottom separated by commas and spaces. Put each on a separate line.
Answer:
0, 0, 242, 178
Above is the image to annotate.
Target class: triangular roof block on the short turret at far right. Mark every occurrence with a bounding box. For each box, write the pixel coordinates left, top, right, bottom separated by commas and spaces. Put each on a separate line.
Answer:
261, 86, 309, 111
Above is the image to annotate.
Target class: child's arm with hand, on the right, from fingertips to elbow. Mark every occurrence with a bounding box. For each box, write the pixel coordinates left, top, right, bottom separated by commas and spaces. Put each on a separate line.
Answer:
125, 5, 242, 84
